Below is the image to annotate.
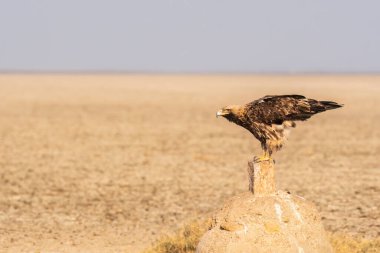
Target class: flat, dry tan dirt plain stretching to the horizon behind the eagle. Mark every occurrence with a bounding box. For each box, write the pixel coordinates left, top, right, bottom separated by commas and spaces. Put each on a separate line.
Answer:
0, 75, 380, 253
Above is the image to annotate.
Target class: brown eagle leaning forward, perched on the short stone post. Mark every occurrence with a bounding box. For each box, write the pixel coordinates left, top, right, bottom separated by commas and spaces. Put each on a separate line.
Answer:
216, 95, 343, 161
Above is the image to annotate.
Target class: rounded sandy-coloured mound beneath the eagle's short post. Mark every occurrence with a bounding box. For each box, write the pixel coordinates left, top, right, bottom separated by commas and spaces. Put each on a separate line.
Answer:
196, 191, 333, 253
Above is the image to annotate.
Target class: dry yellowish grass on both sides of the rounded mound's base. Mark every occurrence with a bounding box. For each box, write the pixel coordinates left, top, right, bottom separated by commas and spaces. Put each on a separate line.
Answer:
144, 221, 380, 253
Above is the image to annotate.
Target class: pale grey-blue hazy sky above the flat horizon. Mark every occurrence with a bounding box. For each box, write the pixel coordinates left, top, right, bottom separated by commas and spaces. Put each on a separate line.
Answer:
0, 0, 380, 72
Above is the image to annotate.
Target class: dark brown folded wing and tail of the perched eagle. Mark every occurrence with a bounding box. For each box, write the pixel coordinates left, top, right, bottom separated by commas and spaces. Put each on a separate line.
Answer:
246, 95, 341, 124
